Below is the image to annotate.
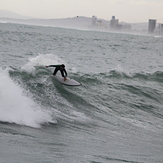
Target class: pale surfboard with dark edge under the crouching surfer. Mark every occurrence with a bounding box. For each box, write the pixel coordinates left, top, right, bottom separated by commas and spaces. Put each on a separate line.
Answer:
52, 75, 81, 86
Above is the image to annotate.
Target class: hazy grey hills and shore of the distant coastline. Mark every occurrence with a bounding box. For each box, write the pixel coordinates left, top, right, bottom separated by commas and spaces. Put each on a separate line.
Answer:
0, 10, 159, 34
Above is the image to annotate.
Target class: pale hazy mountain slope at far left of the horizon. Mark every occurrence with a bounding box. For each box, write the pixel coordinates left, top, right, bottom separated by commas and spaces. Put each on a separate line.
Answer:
0, 10, 33, 19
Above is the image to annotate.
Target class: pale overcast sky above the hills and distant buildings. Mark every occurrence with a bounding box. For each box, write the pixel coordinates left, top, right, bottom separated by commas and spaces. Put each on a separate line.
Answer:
0, 0, 163, 23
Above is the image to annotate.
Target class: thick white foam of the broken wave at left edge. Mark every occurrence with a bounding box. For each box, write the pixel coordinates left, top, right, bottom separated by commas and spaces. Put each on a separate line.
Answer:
0, 69, 53, 127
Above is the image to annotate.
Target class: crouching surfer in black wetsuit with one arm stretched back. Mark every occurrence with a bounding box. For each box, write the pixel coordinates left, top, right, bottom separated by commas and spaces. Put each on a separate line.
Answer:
45, 64, 67, 81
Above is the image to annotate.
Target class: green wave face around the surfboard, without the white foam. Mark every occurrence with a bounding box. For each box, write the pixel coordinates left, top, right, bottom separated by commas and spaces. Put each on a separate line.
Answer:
6, 66, 163, 131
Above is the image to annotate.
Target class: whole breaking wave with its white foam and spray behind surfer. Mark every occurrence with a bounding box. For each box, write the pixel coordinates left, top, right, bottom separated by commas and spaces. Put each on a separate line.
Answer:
0, 54, 163, 131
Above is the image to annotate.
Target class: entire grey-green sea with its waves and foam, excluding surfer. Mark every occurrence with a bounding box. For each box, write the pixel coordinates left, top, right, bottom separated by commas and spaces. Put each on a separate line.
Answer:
0, 23, 163, 163
